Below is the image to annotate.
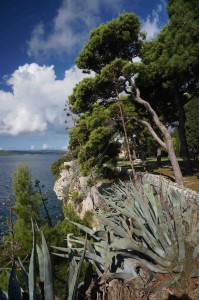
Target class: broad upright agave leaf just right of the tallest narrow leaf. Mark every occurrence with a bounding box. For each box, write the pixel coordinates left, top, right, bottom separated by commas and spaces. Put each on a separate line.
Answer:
41, 231, 55, 300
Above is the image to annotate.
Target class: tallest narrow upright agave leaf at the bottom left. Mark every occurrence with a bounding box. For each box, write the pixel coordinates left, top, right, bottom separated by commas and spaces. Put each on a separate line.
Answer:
28, 219, 37, 300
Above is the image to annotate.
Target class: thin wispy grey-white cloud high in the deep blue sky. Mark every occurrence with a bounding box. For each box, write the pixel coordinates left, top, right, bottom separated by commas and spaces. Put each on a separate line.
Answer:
28, 0, 120, 57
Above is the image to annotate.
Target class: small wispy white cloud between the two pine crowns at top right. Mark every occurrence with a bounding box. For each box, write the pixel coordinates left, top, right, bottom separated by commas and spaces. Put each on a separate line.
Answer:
142, 0, 166, 40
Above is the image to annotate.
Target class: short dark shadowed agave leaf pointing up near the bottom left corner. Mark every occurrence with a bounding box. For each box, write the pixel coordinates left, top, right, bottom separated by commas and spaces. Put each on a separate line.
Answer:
8, 262, 22, 300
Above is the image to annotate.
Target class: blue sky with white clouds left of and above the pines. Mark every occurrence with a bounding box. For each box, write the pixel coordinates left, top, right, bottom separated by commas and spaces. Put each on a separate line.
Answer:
0, 0, 167, 150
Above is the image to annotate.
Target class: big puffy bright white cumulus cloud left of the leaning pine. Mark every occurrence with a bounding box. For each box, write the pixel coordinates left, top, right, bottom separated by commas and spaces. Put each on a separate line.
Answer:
0, 63, 90, 136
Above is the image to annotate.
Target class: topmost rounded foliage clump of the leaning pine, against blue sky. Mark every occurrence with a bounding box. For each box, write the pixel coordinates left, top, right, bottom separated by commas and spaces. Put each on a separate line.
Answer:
76, 13, 144, 73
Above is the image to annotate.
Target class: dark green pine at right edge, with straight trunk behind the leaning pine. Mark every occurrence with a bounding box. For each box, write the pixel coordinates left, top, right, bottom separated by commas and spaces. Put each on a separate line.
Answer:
137, 0, 199, 172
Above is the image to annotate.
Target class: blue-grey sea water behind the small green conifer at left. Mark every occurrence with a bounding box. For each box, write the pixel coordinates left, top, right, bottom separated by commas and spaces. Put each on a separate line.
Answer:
0, 154, 62, 236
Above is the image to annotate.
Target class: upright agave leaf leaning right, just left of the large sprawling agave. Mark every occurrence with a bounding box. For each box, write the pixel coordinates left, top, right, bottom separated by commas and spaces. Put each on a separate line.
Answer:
68, 237, 87, 300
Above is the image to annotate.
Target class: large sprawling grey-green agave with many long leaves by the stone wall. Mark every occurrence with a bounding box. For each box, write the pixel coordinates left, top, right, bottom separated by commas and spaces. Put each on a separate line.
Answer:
52, 179, 199, 299
